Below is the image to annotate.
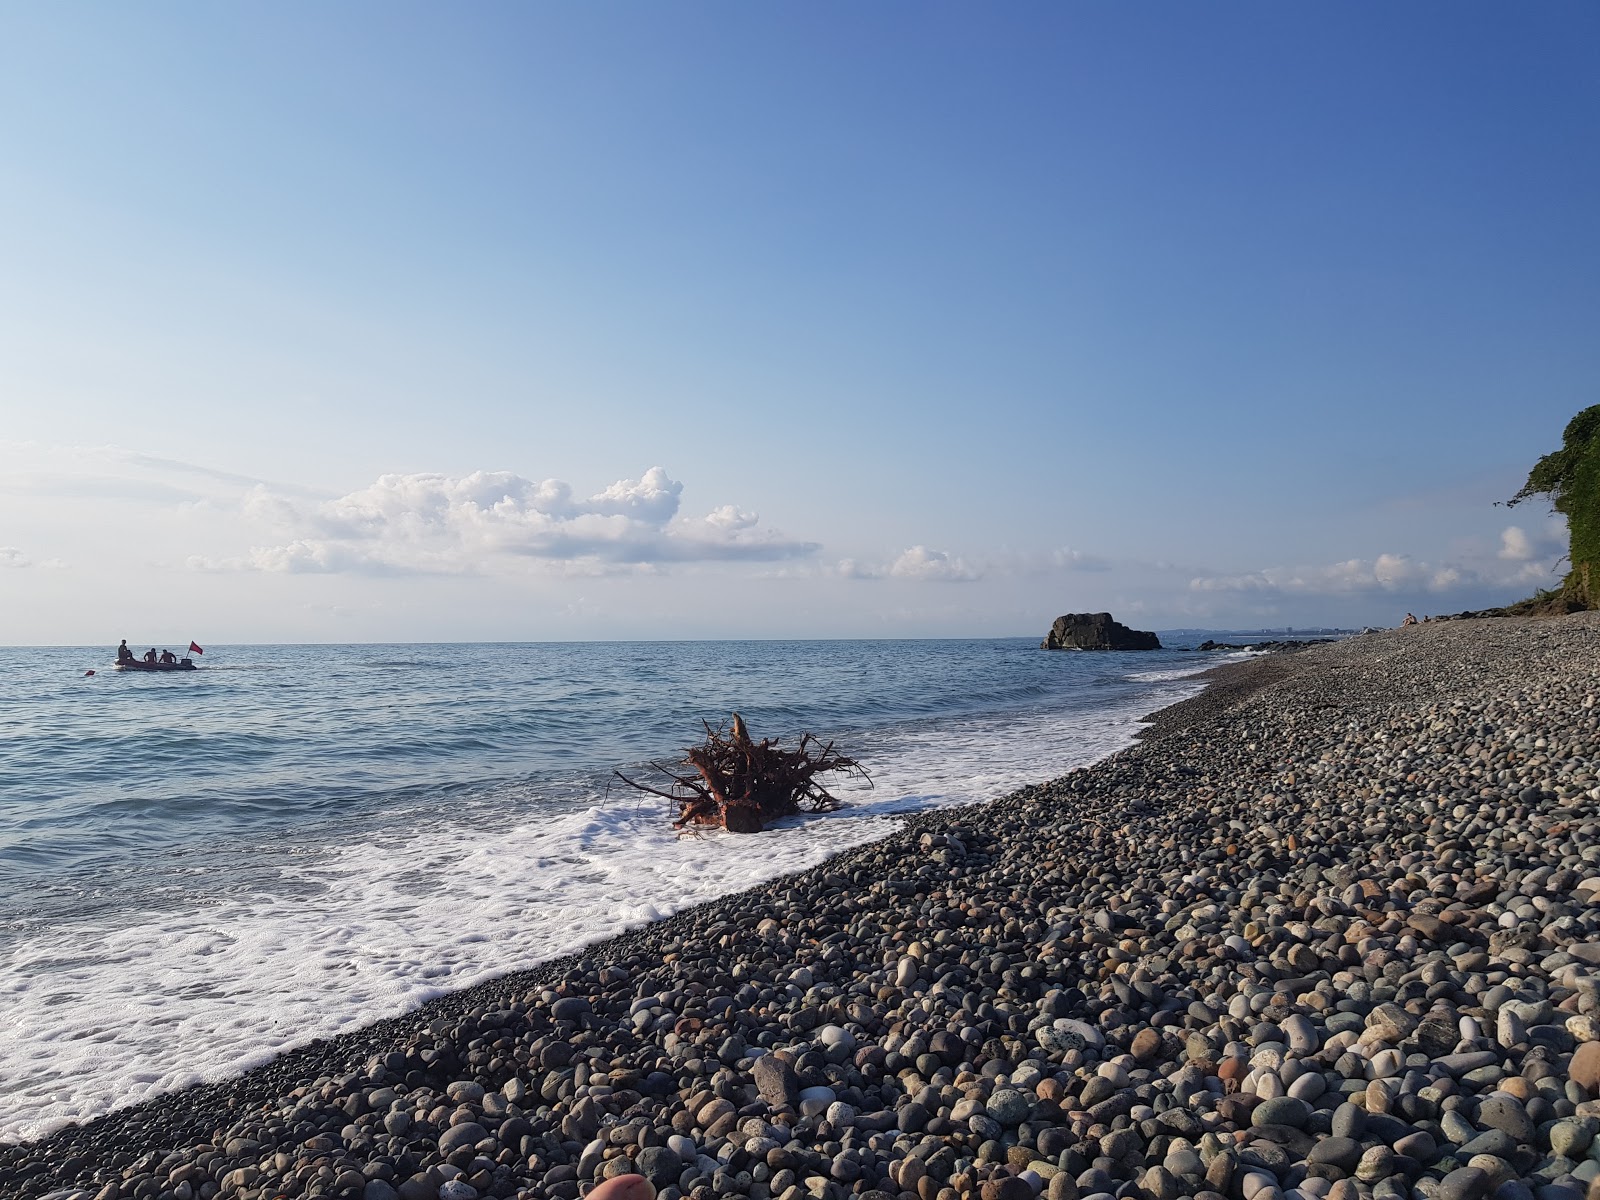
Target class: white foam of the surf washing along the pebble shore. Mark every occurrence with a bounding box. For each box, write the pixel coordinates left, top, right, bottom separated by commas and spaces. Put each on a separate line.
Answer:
0, 672, 1200, 1141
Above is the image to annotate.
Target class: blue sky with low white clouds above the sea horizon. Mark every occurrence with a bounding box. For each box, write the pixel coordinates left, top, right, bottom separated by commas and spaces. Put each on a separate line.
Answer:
0, 0, 1600, 645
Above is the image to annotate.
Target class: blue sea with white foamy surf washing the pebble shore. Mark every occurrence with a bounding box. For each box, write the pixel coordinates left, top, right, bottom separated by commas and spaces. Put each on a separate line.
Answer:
0, 638, 1248, 1142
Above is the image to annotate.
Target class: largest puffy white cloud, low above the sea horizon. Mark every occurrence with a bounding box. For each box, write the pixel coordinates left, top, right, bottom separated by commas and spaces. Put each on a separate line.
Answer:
209, 467, 818, 574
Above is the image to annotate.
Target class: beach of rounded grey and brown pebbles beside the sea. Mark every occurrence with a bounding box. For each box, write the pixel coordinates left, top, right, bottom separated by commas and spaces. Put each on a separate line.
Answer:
9, 613, 1600, 1200
